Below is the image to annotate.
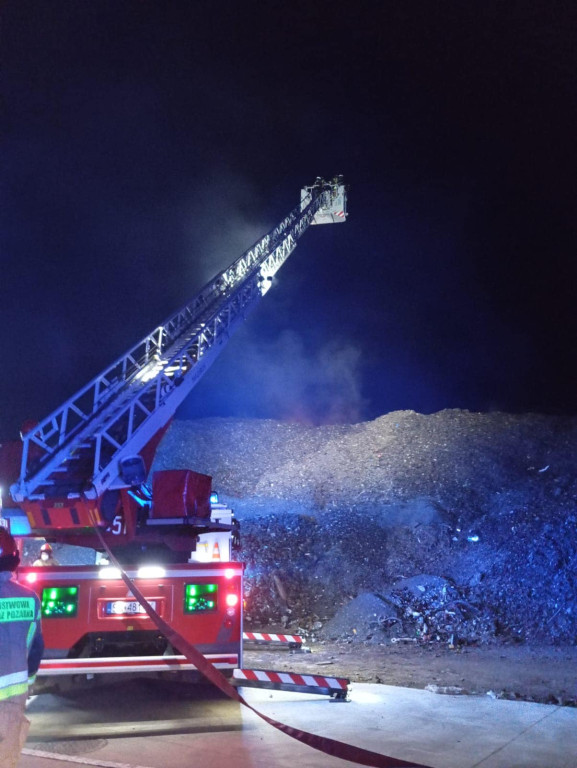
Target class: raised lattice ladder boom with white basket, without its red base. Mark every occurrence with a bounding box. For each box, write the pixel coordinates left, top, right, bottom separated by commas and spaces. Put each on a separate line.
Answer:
11, 177, 346, 502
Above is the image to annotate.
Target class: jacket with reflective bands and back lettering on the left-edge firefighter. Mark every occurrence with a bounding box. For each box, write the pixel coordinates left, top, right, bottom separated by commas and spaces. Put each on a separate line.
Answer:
0, 571, 44, 701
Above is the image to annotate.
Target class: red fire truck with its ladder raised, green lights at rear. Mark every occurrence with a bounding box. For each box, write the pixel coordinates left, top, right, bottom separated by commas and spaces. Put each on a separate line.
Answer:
0, 177, 346, 692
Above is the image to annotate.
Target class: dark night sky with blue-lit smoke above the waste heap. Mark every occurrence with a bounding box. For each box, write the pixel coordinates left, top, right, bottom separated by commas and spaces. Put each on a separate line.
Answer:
0, 0, 577, 436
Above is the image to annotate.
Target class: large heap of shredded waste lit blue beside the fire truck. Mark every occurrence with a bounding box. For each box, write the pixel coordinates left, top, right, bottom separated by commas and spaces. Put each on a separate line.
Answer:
155, 410, 577, 645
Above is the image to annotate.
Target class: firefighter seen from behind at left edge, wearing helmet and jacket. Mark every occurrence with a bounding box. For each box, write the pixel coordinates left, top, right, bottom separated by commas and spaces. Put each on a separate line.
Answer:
0, 527, 44, 768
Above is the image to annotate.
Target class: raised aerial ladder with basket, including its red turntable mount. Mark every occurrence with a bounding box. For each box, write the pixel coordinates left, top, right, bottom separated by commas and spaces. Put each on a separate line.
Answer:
11, 176, 347, 550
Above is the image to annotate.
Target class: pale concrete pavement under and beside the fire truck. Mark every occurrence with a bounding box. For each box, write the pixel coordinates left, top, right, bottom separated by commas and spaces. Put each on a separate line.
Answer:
19, 684, 577, 768
